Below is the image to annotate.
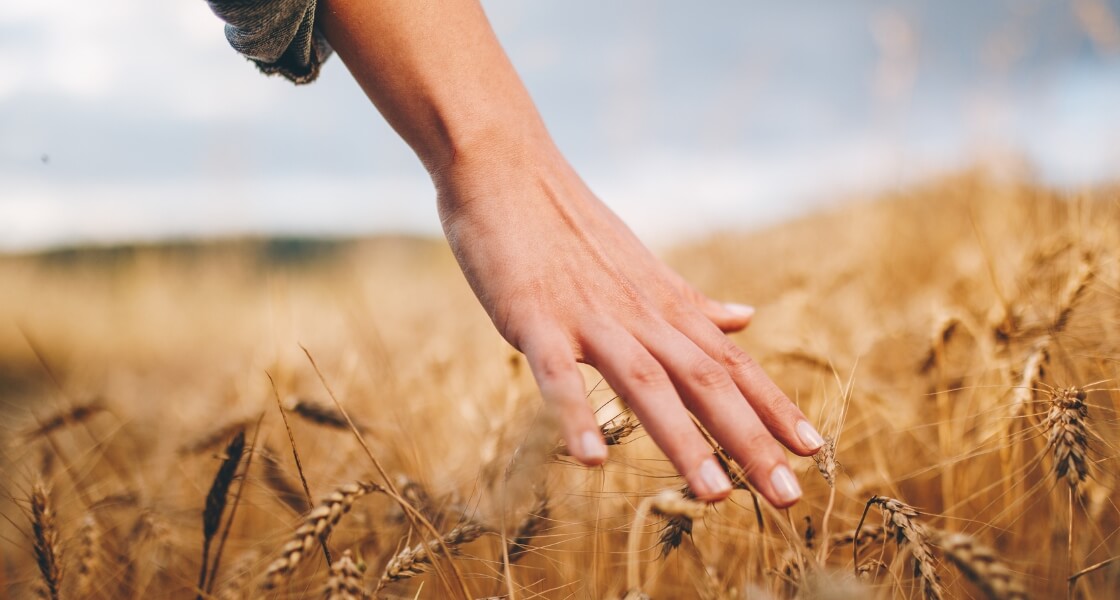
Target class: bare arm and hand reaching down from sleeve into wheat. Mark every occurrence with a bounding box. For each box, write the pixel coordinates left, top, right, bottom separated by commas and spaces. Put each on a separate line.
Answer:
319, 0, 823, 506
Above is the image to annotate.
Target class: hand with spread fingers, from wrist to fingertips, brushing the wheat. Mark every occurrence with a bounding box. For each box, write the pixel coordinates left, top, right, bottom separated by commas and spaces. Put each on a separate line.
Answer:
433, 143, 824, 507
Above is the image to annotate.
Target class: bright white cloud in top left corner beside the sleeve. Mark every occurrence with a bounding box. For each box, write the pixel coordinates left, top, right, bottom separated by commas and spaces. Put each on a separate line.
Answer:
0, 0, 281, 119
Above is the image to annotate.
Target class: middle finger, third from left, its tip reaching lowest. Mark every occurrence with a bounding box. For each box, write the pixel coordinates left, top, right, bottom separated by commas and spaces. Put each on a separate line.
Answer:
640, 325, 801, 508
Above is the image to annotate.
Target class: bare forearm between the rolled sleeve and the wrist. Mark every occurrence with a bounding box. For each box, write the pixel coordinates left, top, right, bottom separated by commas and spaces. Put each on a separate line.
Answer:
318, 0, 551, 178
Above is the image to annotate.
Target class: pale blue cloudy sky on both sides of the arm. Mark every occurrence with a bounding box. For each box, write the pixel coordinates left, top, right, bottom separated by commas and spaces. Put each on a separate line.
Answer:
0, 0, 1120, 251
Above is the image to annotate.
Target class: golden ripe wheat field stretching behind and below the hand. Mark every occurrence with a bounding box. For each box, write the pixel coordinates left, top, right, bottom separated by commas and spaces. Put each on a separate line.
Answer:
0, 172, 1120, 599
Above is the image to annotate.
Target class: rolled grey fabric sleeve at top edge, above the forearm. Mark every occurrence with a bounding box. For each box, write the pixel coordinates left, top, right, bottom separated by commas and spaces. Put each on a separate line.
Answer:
207, 0, 332, 84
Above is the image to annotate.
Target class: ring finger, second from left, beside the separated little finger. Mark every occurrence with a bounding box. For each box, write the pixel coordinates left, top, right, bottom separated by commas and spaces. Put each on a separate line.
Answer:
585, 329, 731, 500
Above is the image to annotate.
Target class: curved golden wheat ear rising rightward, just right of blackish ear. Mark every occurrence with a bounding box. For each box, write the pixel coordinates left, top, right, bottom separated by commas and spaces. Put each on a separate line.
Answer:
262, 481, 384, 590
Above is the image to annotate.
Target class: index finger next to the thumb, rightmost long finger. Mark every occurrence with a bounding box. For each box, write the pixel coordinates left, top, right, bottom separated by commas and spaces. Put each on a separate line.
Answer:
670, 310, 824, 457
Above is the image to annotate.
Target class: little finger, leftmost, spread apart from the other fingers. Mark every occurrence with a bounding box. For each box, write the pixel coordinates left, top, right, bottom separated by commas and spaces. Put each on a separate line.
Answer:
521, 329, 607, 466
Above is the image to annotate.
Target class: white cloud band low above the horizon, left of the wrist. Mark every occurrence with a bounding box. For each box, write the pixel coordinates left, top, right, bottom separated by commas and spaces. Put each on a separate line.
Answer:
0, 177, 439, 251
